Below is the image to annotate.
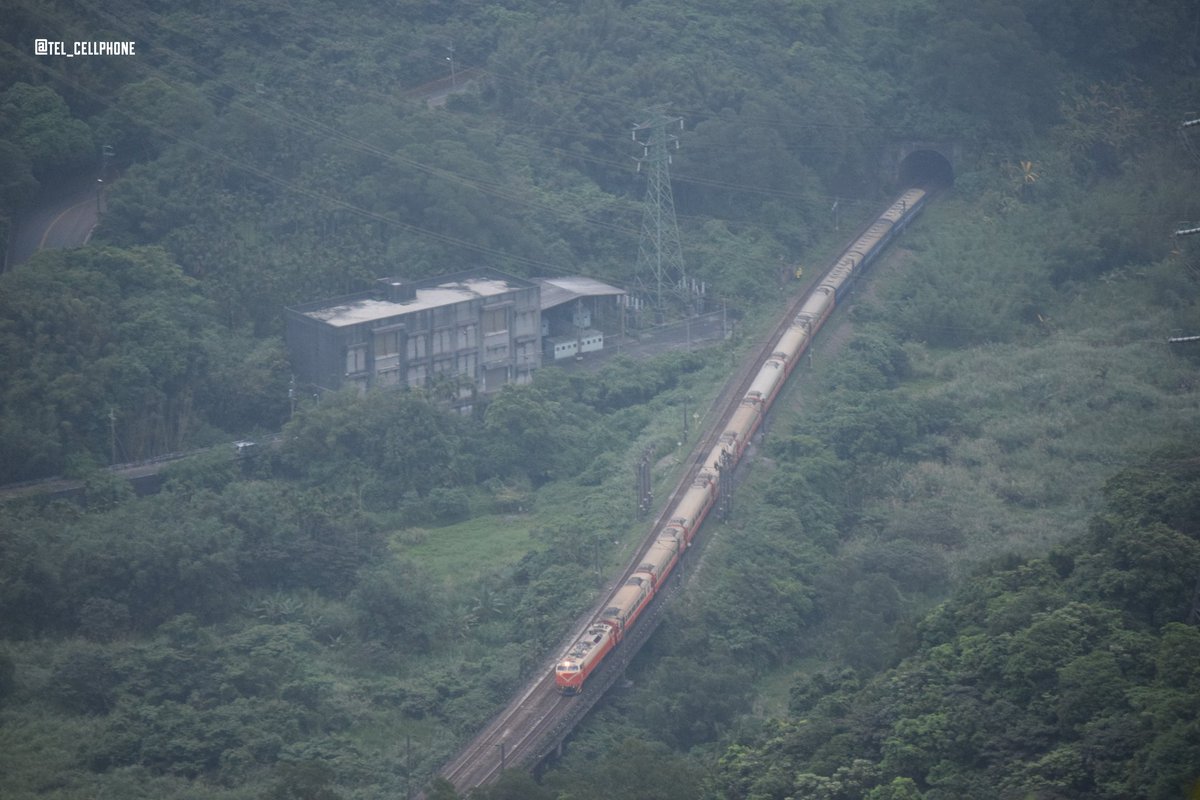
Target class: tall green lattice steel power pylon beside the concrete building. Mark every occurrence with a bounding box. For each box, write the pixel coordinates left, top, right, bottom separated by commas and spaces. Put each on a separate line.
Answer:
634, 109, 686, 323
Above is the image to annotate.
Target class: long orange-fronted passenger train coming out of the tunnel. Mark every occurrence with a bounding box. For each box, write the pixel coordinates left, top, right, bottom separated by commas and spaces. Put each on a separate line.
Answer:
554, 187, 929, 694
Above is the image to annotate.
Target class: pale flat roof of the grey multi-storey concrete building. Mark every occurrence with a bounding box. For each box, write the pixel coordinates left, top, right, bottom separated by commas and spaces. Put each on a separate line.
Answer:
296, 271, 529, 327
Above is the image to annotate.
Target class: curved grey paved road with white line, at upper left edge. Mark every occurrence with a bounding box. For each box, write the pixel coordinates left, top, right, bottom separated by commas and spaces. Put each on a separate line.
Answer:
5, 173, 102, 269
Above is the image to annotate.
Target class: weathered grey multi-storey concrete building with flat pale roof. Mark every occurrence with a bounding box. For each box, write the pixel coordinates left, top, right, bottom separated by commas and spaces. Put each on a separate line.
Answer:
286, 269, 541, 404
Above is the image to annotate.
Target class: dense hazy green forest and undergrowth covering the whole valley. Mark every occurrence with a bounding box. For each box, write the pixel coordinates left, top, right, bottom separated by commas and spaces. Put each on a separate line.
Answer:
0, 0, 1200, 800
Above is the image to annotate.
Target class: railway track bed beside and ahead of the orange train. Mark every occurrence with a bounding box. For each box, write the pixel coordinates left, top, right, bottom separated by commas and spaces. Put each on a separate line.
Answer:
432, 190, 926, 793
